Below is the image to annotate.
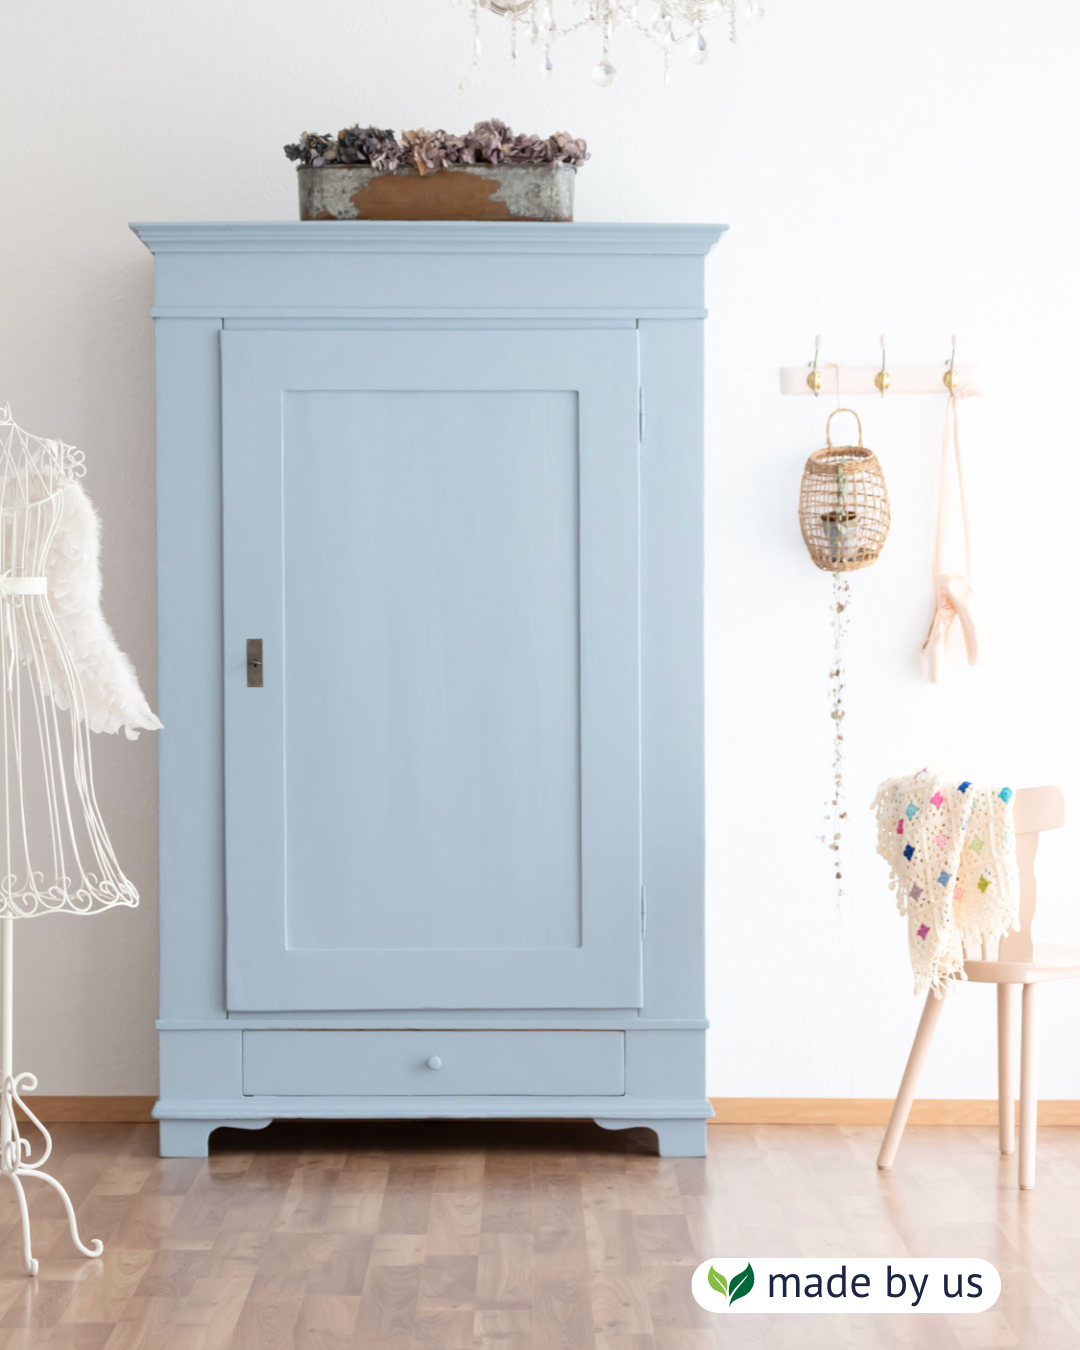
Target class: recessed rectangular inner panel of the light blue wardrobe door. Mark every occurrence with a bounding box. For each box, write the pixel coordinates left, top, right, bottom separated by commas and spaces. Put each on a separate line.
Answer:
284, 390, 582, 950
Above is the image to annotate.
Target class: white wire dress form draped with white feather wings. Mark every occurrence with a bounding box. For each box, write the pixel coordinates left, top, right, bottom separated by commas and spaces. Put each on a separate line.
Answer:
0, 404, 161, 1274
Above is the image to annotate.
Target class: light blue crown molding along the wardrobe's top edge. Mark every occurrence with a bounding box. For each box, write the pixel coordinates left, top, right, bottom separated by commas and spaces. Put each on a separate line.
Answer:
131, 220, 728, 257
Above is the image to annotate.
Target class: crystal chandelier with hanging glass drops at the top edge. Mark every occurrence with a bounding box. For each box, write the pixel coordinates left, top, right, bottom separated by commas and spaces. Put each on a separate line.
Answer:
470, 0, 764, 86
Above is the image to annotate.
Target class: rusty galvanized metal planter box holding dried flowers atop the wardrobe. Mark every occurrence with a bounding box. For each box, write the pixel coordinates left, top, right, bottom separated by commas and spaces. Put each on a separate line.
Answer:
297, 165, 578, 220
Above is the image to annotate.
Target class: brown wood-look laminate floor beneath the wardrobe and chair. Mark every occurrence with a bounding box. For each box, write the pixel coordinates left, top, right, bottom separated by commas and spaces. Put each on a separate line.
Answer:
0, 1122, 1080, 1350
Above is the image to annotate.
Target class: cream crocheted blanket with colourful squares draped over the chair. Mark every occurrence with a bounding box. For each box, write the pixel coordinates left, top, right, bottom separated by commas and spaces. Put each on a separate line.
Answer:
873, 770, 1019, 998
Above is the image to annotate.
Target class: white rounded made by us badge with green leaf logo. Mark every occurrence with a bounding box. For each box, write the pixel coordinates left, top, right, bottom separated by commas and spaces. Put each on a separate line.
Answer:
690, 1257, 1002, 1316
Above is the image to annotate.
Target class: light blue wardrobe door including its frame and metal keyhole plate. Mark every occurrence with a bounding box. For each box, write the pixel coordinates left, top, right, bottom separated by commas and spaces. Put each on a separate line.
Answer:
221, 329, 641, 1011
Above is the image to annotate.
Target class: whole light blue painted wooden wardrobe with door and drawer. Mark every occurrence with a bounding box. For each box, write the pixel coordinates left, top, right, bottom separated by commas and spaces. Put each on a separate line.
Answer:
134, 221, 721, 1156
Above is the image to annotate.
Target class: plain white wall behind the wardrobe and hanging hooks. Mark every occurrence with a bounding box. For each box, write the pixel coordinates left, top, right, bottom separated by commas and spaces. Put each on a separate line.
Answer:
0, 0, 1080, 1098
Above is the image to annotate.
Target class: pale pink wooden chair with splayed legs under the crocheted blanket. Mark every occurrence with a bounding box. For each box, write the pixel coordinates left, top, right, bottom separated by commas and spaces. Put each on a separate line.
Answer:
878, 787, 1080, 1191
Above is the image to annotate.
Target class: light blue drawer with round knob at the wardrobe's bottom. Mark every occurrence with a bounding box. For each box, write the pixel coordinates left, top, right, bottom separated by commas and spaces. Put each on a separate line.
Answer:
243, 1031, 625, 1096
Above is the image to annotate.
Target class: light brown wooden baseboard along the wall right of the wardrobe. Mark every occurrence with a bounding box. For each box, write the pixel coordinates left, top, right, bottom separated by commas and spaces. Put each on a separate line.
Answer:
710, 1098, 1080, 1125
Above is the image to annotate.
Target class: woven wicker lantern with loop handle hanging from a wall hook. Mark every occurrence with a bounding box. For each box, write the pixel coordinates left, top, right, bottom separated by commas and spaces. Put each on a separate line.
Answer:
799, 408, 890, 572
